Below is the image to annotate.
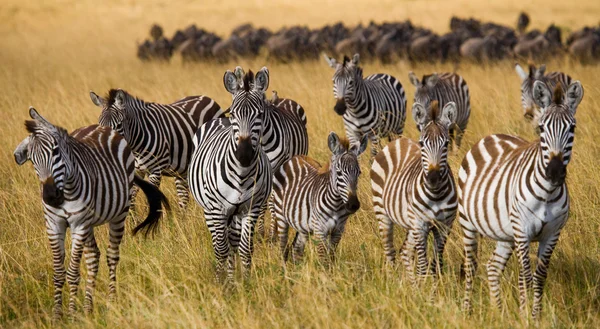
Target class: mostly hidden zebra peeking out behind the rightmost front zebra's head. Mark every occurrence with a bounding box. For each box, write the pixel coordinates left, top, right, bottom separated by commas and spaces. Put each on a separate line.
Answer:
515, 63, 571, 123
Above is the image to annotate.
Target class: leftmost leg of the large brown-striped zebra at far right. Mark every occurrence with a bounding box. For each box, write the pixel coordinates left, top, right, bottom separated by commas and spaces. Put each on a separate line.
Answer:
459, 211, 479, 312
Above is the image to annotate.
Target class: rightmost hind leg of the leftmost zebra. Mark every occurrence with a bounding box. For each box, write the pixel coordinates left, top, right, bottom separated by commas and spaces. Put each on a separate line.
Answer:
106, 217, 127, 302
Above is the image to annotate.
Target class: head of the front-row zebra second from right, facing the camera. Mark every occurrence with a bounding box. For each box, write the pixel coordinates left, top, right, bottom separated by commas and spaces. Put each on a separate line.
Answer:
413, 101, 457, 189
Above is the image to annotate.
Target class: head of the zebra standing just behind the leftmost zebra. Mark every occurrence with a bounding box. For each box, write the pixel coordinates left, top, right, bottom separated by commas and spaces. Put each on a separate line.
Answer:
90, 89, 131, 136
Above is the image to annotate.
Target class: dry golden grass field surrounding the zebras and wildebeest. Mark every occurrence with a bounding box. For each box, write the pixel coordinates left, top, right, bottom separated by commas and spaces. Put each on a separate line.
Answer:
0, 0, 600, 328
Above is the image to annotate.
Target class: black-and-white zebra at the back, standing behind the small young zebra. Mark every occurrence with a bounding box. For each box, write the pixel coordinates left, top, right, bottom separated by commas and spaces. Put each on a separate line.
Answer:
324, 54, 406, 156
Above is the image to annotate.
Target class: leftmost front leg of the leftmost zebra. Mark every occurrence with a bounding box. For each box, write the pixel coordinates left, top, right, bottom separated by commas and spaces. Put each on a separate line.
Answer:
46, 220, 67, 320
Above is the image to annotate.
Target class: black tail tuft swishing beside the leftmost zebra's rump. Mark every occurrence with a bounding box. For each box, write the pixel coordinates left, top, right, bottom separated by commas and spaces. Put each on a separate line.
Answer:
133, 175, 171, 237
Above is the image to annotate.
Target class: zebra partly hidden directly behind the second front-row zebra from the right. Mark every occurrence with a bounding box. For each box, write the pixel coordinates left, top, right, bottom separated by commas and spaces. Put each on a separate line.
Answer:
408, 72, 471, 149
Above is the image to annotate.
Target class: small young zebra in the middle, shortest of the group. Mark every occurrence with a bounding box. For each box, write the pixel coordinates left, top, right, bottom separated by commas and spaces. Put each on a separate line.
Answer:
271, 132, 368, 261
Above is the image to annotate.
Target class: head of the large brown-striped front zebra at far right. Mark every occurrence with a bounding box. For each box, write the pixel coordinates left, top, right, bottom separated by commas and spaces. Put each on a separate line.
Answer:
533, 81, 583, 186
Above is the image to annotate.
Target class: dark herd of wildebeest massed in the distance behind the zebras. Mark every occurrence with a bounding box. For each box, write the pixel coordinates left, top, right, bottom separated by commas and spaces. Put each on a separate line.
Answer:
137, 13, 600, 63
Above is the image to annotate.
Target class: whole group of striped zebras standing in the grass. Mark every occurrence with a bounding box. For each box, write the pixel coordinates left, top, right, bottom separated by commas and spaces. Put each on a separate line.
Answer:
14, 54, 583, 317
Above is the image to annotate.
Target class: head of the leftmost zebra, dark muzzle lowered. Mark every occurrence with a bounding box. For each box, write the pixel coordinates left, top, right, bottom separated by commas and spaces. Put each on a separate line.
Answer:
14, 107, 68, 208
